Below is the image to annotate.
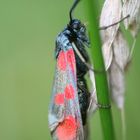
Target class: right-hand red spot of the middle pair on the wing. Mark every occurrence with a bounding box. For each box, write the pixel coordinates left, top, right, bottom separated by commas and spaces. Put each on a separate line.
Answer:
64, 84, 74, 99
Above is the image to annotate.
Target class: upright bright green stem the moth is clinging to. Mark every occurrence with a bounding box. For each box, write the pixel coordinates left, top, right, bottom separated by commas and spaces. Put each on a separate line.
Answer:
86, 0, 115, 140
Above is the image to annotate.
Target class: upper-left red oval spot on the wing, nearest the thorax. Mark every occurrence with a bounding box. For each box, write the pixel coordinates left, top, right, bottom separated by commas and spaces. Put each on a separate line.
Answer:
57, 51, 67, 71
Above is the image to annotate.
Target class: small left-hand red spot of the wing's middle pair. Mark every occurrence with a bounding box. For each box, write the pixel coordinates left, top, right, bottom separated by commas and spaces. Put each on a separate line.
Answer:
54, 93, 64, 105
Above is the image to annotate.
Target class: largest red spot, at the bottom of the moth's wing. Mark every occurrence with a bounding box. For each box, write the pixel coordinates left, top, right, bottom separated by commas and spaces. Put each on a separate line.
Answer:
56, 115, 77, 140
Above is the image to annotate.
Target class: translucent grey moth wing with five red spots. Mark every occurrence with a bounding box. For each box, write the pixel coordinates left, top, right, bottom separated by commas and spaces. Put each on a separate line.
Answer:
49, 46, 84, 140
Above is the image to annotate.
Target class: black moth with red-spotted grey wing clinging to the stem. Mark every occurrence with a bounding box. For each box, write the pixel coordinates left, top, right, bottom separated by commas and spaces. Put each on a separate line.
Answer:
49, 1, 90, 140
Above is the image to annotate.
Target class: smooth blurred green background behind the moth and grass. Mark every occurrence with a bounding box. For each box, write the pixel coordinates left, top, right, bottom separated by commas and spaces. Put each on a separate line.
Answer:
0, 0, 140, 140
